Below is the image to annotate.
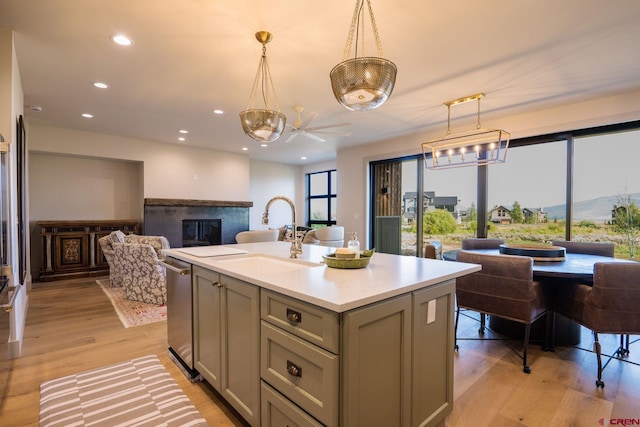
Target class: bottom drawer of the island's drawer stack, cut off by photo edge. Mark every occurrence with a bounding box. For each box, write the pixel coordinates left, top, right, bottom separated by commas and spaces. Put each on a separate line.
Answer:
261, 381, 322, 427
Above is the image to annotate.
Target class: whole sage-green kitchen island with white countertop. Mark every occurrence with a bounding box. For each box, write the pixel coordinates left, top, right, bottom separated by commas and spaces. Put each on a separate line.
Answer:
166, 242, 480, 426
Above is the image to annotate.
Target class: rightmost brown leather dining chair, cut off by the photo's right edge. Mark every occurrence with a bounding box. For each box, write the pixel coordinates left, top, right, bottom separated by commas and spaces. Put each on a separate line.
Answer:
554, 262, 640, 388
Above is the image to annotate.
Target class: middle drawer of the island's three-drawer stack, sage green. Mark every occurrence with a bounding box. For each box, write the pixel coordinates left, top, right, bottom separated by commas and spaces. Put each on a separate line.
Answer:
260, 321, 339, 425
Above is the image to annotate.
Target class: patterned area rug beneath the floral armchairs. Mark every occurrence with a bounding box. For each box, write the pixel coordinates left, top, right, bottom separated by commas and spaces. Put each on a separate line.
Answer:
96, 279, 167, 328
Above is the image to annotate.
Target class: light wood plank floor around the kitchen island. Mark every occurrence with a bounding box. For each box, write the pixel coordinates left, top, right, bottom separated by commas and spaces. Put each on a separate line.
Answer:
0, 279, 640, 427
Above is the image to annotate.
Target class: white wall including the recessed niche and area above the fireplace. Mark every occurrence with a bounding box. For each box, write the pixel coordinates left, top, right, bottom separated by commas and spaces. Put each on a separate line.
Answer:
27, 122, 258, 280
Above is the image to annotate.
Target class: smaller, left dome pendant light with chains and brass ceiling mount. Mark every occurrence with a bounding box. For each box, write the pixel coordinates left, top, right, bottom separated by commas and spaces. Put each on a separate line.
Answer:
240, 31, 287, 142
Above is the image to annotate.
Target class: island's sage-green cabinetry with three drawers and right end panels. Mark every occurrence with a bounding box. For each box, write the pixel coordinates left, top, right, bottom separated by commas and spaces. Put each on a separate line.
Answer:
261, 280, 455, 427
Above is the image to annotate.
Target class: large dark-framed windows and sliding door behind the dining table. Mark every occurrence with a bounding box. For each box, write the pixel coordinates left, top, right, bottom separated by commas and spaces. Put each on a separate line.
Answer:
370, 121, 640, 259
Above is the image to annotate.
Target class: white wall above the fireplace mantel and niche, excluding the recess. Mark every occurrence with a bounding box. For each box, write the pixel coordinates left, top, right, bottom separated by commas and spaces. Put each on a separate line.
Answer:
28, 122, 250, 201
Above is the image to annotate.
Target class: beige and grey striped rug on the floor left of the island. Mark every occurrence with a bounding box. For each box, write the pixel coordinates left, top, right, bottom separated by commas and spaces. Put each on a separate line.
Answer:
40, 355, 208, 427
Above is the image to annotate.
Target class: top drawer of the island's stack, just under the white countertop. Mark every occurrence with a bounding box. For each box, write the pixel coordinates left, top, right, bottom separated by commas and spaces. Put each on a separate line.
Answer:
260, 289, 339, 354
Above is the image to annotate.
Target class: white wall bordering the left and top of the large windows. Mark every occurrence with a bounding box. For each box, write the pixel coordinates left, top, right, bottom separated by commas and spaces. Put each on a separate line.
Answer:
336, 91, 640, 248
